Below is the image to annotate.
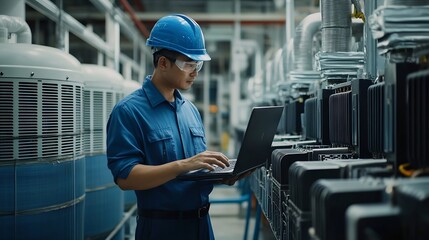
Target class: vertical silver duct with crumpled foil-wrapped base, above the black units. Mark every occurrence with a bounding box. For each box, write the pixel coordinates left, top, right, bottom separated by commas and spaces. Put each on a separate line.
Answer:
315, 0, 365, 85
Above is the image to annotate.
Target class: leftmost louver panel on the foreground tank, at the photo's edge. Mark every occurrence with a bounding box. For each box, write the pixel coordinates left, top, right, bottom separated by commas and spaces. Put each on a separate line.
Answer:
0, 82, 13, 161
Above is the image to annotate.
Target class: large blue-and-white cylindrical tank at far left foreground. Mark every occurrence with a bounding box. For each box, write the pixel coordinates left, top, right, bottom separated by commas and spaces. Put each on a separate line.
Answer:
0, 43, 85, 239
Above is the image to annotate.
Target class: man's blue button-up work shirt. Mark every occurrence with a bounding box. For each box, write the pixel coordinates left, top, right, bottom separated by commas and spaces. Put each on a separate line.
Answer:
107, 76, 213, 239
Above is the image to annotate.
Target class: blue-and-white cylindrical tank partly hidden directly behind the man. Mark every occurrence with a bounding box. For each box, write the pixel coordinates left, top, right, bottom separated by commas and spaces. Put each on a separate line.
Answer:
82, 64, 124, 239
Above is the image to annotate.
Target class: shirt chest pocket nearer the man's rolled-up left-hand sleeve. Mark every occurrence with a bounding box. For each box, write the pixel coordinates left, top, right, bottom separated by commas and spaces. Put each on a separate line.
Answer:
148, 128, 176, 164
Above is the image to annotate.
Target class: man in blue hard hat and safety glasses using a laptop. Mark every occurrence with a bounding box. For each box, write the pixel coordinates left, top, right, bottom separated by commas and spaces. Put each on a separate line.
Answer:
107, 15, 242, 240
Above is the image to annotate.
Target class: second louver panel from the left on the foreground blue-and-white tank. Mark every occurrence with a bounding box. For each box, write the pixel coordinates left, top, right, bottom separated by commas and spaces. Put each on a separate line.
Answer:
18, 82, 38, 160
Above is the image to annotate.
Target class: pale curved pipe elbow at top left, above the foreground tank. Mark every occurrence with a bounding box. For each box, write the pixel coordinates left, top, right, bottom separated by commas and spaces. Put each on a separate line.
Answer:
0, 15, 31, 44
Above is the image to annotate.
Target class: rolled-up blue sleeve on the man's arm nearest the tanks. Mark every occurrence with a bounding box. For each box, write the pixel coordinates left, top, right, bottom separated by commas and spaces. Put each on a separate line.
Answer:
106, 104, 145, 182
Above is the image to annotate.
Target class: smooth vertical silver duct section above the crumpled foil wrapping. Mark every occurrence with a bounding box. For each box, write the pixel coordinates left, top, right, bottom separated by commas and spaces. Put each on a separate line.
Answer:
320, 0, 352, 52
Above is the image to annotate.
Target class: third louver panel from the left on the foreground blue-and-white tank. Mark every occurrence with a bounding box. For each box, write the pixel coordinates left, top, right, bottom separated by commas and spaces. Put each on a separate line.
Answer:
42, 83, 59, 158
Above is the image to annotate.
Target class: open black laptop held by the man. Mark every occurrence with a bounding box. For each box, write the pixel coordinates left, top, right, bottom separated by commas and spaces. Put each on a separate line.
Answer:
177, 106, 283, 180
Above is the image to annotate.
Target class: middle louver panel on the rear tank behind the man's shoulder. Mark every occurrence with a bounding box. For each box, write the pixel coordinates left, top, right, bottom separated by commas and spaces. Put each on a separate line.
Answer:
92, 91, 104, 152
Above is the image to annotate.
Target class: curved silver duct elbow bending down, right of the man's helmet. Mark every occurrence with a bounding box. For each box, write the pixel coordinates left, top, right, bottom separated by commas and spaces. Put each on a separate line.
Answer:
294, 13, 321, 71
